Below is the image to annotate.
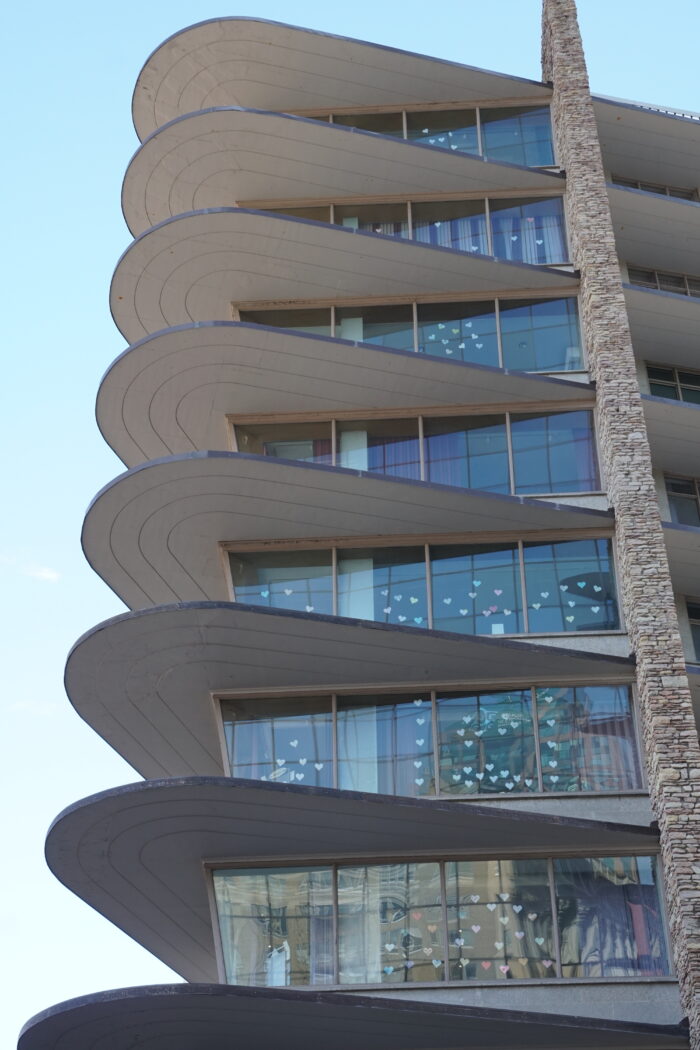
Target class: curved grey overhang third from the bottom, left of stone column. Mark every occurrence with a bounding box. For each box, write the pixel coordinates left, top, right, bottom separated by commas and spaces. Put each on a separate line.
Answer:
65, 603, 634, 777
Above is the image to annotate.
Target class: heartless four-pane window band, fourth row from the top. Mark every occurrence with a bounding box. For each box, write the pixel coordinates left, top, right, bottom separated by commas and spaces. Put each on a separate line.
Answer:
235, 410, 599, 496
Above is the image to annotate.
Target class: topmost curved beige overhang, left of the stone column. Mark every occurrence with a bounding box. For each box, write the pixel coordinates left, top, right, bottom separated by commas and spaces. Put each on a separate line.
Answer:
132, 18, 552, 141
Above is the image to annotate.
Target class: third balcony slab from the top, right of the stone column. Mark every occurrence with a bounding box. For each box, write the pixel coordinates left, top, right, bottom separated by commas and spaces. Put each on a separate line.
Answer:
623, 285, 700, 369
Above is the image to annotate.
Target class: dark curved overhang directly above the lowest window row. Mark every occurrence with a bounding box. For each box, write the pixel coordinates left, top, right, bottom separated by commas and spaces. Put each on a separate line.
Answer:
46, 777, 658, 981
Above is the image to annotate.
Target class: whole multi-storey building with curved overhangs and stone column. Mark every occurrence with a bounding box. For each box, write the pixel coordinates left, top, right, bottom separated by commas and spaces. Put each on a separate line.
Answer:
19, 0, 700, 1050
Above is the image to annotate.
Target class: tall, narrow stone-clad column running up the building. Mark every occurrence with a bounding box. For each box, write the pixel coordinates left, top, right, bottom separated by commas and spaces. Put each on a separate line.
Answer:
543, 0, 700, 1048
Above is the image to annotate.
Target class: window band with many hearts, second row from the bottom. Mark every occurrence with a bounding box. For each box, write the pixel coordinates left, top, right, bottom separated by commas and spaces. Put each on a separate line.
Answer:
221, 685, 641, 800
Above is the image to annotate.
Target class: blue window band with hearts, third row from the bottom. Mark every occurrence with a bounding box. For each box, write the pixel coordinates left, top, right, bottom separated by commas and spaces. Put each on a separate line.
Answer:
230, 540, 619, 634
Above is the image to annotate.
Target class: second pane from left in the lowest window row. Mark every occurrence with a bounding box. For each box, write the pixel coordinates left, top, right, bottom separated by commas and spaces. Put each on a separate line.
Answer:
338, 864, 445, 984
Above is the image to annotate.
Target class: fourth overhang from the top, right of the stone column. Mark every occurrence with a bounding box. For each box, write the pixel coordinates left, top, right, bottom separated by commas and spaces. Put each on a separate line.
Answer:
641, 394, 700, 478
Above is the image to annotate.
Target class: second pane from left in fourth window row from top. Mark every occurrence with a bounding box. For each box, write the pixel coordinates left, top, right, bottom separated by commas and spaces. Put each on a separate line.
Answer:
336, 419, 421, 481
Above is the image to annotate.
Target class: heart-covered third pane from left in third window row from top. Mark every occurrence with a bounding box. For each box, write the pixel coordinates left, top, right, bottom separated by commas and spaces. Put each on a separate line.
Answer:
418, 302, 499, 369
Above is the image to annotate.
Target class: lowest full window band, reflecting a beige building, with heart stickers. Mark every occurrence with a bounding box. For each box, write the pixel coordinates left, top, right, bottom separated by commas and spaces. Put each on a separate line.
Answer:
213, 857, 670, 987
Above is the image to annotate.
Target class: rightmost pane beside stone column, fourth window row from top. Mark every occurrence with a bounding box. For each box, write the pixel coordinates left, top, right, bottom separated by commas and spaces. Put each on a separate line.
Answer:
510, 412, 599, 496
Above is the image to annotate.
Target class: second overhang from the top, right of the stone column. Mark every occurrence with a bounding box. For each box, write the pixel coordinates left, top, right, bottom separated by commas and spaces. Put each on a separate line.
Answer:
608, 185, 700, 273
